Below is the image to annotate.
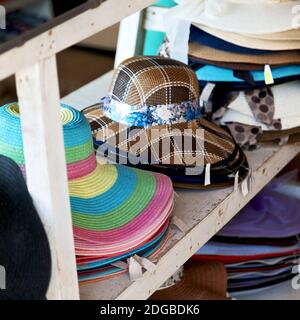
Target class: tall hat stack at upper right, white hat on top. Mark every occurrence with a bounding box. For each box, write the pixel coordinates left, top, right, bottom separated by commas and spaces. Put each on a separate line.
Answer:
165, 0, 300, 149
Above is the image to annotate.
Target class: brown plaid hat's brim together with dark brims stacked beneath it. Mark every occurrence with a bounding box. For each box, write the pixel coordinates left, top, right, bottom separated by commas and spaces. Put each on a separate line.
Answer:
83, 104, 249, 189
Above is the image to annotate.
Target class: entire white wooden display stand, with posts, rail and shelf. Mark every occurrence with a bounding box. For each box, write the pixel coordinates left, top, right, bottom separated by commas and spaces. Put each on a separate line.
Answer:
0, 0, 300, 299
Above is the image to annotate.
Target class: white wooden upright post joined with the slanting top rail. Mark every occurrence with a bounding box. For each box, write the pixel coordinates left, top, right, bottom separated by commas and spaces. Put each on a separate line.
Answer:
0, 0, 155, 299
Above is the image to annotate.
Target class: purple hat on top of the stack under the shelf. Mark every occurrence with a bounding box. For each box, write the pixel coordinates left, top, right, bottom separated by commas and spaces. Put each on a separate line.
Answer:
218, 172, 300, 243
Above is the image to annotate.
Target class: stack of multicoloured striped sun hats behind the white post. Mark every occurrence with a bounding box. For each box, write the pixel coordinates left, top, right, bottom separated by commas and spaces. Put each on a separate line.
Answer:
0, 103, 173, 282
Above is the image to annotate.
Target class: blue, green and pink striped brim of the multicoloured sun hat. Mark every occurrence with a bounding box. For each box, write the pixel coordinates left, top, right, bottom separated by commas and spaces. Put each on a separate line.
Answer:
71, 166, 174, 256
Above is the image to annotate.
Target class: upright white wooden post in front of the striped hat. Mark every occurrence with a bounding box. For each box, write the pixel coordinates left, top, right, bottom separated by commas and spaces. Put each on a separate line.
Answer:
16, 55, 79, 299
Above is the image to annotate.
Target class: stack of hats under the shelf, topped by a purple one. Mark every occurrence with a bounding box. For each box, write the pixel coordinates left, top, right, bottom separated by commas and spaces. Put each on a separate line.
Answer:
192, 174, 300, 292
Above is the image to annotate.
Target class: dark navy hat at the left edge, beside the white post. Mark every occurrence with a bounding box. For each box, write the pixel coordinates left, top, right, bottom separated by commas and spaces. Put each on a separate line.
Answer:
0, 155, 51, 300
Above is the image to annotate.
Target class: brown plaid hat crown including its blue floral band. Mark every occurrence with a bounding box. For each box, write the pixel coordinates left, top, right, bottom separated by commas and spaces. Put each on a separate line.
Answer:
103, 57, 201, 127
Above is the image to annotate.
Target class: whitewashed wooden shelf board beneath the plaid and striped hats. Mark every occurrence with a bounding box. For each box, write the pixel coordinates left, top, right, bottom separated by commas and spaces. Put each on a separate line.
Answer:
63, 72, 300, 300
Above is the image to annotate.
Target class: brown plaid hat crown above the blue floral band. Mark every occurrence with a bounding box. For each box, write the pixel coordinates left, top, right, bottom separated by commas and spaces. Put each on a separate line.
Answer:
109, 56, 199, 106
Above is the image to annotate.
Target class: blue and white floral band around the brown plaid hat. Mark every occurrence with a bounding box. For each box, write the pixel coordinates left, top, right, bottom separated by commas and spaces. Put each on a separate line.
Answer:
102, 97, 202, 127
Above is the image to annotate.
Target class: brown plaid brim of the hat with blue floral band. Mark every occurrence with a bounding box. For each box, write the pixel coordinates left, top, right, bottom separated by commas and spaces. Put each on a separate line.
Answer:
83, 105, 235, 166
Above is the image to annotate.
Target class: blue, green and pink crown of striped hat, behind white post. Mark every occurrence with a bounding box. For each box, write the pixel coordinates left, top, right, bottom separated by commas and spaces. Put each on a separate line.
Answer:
0, 103, 96, 177
